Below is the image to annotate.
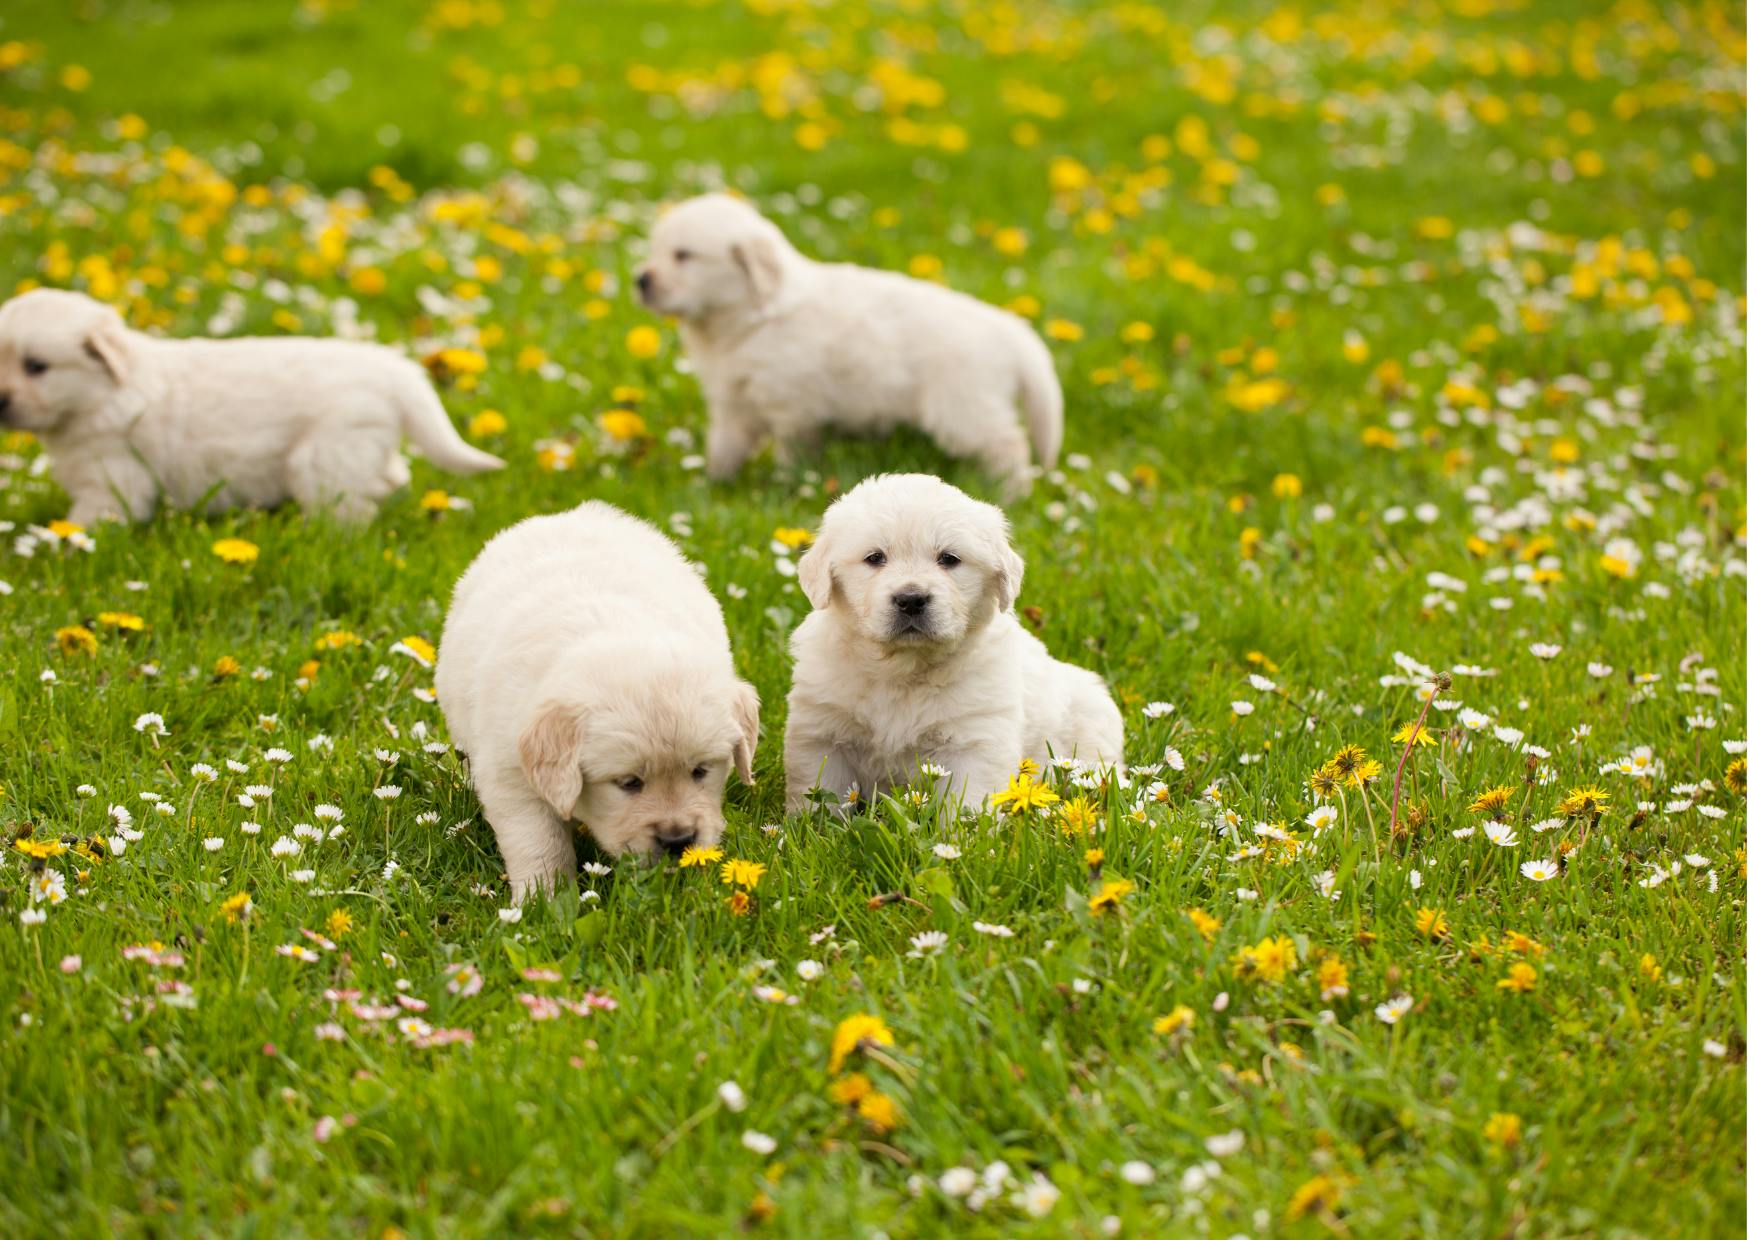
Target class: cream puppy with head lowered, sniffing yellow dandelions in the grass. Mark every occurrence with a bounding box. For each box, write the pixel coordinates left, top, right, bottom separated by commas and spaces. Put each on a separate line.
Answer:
437, 502, 759, 901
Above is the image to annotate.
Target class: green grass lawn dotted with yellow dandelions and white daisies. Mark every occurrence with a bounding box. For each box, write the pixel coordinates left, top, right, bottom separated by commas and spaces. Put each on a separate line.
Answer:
0, 0, 1748, 1237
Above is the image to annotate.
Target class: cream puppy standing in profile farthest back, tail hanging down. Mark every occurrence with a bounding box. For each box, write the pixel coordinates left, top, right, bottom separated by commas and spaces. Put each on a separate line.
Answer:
638, 194, 1063, 500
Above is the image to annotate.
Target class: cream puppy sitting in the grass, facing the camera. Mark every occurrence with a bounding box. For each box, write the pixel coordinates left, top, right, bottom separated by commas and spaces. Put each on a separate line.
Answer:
785, 474, 1122, 808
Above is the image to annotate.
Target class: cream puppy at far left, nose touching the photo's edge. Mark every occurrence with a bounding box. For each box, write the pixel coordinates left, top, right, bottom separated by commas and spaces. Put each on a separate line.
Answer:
0, 289, 503, 525
